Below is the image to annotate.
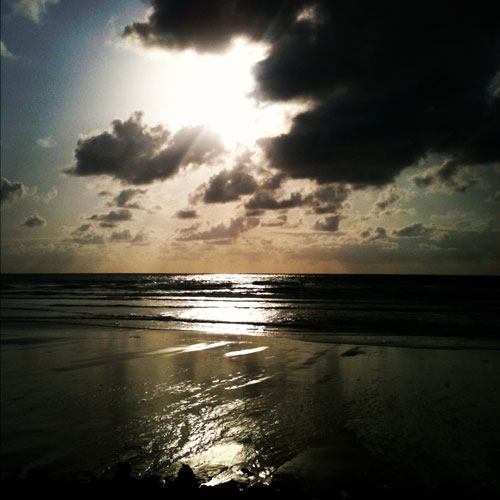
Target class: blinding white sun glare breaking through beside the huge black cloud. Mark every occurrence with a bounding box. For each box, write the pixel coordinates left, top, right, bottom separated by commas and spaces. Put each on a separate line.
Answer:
135, 39, 304, 148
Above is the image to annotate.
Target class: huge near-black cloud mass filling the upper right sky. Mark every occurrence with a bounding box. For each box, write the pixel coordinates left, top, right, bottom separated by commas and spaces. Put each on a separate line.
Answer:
124, 0, 500, 187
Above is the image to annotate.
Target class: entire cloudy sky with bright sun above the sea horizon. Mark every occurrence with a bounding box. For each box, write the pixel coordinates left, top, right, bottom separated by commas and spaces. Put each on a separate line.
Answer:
1, 0, 500, 274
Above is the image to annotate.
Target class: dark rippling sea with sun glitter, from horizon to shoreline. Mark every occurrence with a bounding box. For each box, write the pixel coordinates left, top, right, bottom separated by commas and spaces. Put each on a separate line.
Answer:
1, 274, 500, 346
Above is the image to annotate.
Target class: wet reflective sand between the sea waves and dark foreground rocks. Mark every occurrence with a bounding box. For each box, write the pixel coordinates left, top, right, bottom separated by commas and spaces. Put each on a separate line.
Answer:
1, 325, 500, 491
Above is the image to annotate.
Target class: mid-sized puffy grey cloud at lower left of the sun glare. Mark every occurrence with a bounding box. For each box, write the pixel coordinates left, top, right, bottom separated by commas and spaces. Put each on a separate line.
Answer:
66, 112, 223, 184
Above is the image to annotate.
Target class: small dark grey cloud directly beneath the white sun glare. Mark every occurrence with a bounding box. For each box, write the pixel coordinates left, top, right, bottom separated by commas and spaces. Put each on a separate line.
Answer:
192, 165, 258, 203
